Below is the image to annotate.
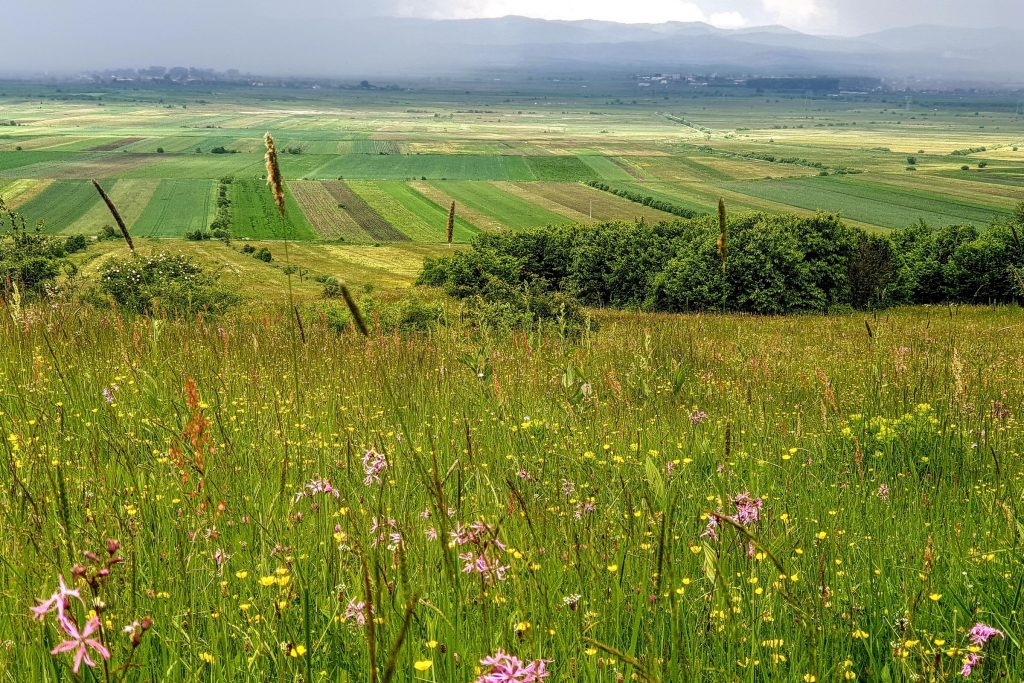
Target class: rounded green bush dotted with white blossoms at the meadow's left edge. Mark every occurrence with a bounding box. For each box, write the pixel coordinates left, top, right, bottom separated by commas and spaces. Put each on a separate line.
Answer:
99, 254, 240, 315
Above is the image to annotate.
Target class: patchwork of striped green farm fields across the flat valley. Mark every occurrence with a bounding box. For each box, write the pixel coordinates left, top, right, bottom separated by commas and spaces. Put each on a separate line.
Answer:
0, 82, 1024, 243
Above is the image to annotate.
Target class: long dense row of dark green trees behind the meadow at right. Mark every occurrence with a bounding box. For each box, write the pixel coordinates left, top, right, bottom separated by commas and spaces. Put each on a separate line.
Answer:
418, 205, 1024, 314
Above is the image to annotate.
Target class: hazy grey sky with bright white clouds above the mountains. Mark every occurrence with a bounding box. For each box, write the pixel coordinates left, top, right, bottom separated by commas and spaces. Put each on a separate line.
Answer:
0, 0, 1024, 73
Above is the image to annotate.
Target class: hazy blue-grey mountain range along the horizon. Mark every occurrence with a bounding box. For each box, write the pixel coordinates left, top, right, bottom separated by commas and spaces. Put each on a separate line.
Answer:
311, 16, 1024, 84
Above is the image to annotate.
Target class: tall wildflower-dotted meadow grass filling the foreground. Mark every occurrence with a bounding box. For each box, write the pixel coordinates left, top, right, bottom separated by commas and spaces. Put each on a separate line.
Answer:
0, 306, 1024, 682
